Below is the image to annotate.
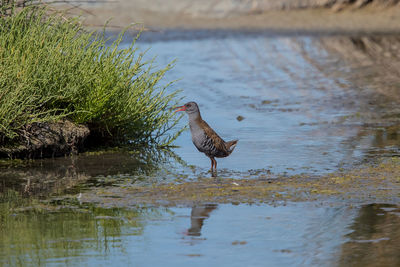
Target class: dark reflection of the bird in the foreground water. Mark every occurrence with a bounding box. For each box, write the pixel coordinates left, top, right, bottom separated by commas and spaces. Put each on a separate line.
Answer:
186, 204, 218, 236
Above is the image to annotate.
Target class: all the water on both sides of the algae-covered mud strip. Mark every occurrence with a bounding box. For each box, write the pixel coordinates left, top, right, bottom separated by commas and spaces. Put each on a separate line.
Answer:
0, 31, 400, 266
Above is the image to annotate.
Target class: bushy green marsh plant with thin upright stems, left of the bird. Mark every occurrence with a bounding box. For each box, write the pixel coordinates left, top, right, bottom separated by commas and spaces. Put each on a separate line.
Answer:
0, 1, 180, 157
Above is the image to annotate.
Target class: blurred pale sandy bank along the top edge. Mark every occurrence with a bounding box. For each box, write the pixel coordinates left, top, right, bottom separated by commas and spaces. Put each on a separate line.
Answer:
60, 0, 400, 33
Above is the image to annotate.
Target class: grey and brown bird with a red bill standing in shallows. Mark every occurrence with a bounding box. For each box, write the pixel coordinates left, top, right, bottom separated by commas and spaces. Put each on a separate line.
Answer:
175, 101, 239, 176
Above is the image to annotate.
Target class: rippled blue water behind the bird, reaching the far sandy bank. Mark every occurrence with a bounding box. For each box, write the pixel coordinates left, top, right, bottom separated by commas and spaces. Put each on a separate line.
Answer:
134, 32, 400, 176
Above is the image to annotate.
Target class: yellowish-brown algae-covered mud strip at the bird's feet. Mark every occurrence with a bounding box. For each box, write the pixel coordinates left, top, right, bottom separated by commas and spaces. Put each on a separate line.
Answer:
76, 158, 400, 207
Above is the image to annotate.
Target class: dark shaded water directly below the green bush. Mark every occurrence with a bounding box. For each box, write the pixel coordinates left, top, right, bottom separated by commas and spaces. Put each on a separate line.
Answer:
0, 150, 185, 197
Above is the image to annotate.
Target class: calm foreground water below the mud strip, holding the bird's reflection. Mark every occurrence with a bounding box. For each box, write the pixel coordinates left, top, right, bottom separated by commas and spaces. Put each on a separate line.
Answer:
0, 203, 400, 266
